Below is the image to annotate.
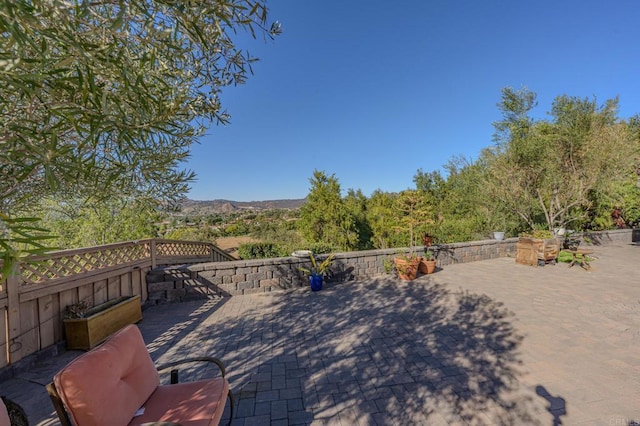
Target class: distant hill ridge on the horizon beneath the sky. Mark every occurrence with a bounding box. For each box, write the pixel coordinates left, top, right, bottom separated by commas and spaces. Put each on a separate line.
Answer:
176, 198, 307, 215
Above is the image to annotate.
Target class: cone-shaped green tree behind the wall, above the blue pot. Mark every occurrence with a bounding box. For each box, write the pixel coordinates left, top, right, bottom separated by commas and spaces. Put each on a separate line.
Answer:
298, 170, 358, 250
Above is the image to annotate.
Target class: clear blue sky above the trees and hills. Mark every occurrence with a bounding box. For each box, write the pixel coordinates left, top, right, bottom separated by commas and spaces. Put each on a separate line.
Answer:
186, 0, 640, 201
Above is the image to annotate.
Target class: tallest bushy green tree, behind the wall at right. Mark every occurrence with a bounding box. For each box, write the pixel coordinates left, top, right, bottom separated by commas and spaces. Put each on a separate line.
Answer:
482, 88, 640, 230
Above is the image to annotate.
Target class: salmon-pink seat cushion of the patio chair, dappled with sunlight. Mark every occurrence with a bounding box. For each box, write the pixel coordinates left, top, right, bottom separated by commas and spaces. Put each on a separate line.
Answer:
129, 377, 229, 426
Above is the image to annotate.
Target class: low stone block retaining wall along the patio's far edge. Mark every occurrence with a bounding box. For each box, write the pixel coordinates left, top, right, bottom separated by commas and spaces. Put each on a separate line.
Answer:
147, 229, 635, 304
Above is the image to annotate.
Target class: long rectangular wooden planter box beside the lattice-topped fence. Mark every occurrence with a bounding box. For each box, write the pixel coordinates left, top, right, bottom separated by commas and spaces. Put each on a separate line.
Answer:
64, 295, 142, 350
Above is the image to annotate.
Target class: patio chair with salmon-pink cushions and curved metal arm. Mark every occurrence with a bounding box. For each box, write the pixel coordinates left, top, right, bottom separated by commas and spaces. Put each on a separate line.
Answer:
47, 325, 233, 426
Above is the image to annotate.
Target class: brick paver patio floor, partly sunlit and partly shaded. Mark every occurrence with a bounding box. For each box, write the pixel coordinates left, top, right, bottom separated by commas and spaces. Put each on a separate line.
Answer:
0, 241, 640, 426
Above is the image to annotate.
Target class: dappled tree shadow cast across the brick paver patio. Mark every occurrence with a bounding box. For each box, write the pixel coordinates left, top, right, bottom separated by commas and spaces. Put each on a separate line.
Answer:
164, 277, 548, 425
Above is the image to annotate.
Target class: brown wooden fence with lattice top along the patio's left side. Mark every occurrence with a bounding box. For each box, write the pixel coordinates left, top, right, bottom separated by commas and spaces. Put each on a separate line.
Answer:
0, 239, 232, 368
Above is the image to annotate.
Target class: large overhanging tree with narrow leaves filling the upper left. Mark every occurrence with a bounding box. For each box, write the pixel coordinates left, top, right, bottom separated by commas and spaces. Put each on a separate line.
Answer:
0, 0, 280, 272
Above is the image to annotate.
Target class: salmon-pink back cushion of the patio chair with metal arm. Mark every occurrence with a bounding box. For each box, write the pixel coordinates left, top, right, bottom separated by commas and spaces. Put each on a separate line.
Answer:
53, 325, 160, 426
